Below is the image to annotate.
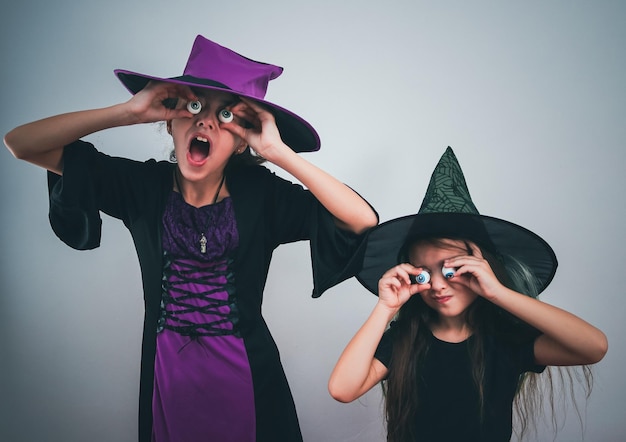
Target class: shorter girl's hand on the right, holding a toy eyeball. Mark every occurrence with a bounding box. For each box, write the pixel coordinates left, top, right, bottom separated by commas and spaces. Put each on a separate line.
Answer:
443, 243, 505, 301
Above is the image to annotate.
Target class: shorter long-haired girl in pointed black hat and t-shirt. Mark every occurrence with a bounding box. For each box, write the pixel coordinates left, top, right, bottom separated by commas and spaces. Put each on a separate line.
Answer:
329, 148, 608, 442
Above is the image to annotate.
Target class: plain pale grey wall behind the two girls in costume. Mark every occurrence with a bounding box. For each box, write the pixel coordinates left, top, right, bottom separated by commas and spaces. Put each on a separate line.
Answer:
0, 0, 626, 442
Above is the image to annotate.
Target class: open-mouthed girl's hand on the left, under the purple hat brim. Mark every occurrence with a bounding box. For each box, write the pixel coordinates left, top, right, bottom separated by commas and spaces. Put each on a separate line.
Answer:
126, 81, 198, 123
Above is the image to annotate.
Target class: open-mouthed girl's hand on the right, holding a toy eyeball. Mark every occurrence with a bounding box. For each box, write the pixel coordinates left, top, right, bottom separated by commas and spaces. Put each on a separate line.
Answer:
220, 98, 290, 161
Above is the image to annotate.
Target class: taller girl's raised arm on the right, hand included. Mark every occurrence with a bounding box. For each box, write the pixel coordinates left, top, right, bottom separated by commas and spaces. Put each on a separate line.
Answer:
224, 99, 378, 233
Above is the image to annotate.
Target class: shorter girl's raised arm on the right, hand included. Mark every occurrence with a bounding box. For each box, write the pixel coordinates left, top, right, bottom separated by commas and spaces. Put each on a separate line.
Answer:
444, 246, 608, 365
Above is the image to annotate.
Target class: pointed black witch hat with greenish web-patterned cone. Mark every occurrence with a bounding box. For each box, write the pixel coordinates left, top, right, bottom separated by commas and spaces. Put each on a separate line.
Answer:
357, 147, 557, 295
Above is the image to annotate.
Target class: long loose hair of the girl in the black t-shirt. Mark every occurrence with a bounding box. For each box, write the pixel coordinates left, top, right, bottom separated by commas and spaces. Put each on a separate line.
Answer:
381, 238, 593, 442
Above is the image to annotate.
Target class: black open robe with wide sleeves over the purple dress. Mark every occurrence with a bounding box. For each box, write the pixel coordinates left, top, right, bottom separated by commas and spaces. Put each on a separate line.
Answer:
48, 141, 364, 442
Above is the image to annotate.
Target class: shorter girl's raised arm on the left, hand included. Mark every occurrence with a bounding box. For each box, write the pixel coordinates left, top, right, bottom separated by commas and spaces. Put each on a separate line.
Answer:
328, 264, 422, 402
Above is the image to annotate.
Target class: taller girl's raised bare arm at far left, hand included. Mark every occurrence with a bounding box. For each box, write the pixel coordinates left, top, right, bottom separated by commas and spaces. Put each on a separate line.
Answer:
4, 83, 195, 174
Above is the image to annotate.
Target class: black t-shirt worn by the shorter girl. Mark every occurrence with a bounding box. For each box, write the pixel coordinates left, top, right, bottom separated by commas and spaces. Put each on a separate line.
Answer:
375, 324, 545, 442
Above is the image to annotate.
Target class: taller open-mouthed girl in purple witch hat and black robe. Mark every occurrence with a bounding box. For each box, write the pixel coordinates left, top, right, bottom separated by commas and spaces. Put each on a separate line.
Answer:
4, 36, 378, 442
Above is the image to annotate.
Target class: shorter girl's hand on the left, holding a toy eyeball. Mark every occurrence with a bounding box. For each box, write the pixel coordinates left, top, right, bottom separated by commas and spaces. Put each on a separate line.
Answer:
378, 263, 430, 314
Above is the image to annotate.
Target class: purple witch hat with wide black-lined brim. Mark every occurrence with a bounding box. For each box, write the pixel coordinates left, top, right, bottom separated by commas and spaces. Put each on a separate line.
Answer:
115, 35, 320, 152
